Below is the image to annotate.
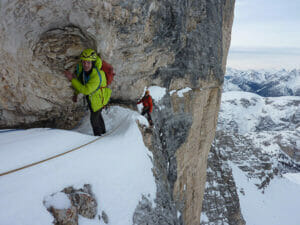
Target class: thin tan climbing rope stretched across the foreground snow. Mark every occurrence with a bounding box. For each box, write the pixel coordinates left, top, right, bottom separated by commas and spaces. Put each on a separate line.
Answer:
0, 118, 122, 177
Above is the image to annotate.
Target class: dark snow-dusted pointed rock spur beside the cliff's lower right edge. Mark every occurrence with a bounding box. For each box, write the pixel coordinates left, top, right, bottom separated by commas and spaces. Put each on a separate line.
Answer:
200, 146, 246, 225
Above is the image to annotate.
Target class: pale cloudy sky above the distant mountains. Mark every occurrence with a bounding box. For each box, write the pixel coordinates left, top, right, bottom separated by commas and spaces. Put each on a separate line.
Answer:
227, 0, 300, 69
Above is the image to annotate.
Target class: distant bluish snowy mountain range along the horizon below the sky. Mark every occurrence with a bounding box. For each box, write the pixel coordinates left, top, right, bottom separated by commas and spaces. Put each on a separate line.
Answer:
223, 68, 300, 97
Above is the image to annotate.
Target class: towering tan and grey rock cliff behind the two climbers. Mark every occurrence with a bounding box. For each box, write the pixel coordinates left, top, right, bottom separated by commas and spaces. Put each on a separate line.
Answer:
0, 0, 235, 225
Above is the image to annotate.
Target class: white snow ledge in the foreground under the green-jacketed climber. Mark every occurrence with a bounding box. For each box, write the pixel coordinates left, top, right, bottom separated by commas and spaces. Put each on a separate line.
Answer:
0, 107, 156, 225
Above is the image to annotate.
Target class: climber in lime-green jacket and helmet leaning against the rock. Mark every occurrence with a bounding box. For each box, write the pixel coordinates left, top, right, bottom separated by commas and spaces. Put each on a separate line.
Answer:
65, 49, 111, 136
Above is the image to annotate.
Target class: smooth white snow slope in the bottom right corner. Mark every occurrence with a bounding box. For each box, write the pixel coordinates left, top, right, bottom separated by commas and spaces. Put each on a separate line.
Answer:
230, 163, 300, 225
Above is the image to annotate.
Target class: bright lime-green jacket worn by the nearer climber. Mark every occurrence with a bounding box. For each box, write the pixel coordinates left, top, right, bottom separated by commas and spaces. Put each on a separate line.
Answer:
72, 58, 111, 112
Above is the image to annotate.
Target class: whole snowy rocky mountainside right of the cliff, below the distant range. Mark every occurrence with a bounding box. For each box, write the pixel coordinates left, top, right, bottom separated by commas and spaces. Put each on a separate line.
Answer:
201, 89, 300, 225
